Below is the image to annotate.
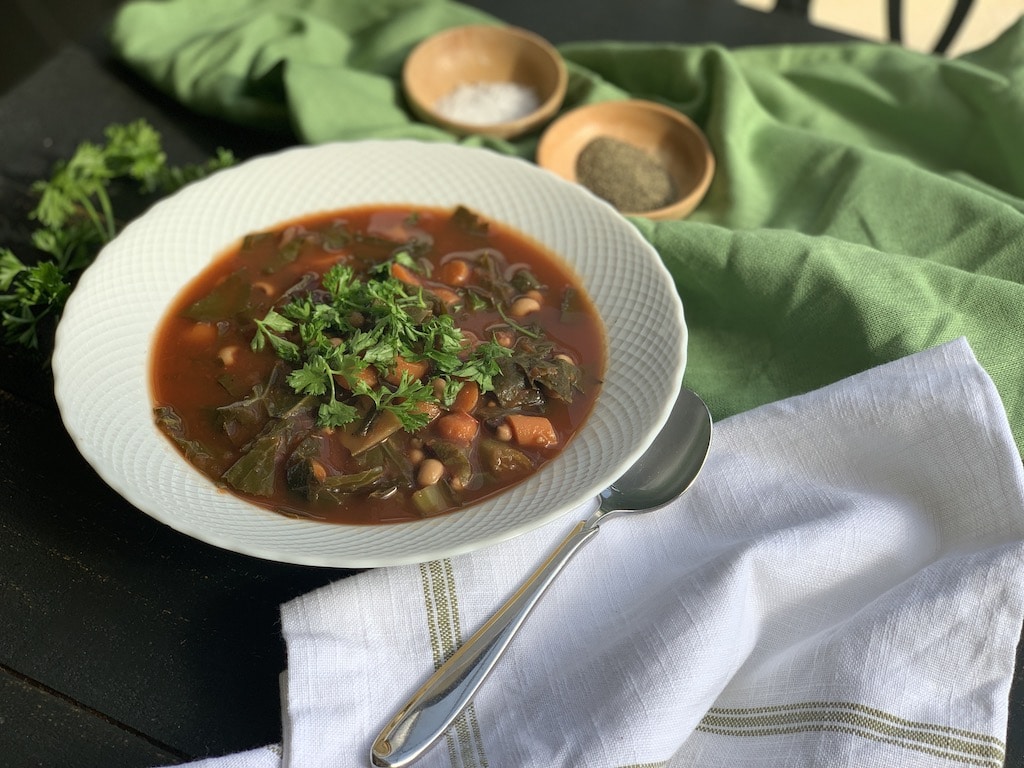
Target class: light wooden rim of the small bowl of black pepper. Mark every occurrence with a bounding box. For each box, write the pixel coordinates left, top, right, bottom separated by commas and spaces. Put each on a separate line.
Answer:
537, 98, 717, 219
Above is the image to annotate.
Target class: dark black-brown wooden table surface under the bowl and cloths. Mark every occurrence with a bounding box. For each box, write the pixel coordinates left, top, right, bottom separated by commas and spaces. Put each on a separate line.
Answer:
0, 0, 1024, 768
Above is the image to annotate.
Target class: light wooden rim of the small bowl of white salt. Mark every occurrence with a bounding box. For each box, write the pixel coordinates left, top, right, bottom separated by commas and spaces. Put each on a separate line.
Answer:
401, 24, 568, 138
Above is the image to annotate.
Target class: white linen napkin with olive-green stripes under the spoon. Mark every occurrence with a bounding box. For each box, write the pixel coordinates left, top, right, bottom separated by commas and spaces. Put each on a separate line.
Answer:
155, 339, 1024, 768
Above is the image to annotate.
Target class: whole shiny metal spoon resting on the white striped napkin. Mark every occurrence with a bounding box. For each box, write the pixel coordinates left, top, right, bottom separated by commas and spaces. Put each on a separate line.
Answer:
370, 388, 712, 768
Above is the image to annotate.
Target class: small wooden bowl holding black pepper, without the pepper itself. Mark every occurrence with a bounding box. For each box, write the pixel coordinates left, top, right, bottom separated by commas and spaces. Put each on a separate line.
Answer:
537, 99, 715, 219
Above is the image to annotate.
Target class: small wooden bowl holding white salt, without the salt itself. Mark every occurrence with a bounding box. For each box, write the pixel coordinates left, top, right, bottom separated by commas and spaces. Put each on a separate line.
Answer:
401, 25, 568, 138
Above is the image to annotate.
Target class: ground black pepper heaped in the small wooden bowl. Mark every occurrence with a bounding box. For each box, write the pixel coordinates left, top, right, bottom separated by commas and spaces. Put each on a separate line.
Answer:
575, 136, 678, 212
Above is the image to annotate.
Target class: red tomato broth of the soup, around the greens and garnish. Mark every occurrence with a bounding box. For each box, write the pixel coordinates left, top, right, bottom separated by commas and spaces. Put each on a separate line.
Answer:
151, 206, 605, 524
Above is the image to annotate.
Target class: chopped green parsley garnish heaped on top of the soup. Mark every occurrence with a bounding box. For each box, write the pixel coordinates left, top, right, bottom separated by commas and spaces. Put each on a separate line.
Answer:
252, 257, 512, 432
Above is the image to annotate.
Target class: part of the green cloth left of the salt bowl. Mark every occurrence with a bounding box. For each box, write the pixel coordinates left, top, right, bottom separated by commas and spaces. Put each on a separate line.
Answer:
112, 0, 492, 138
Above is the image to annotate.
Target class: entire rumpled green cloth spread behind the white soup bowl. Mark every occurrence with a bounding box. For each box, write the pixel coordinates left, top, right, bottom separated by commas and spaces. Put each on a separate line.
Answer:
113, 0, 1024, 447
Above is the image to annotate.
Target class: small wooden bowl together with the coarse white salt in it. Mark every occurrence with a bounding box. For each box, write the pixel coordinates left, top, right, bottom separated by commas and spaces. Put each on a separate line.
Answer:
402, 25, 568, 138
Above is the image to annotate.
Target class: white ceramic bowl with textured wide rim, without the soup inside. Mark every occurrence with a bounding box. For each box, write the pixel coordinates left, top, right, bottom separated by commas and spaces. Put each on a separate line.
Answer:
53, 140, 687, 568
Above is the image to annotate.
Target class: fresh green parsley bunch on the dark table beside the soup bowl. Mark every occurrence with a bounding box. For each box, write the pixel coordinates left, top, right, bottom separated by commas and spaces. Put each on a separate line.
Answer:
0, 120, 234, 349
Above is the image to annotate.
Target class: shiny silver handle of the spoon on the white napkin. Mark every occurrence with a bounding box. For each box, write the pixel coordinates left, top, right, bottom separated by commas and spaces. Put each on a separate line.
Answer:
370, 520, 597, 768
